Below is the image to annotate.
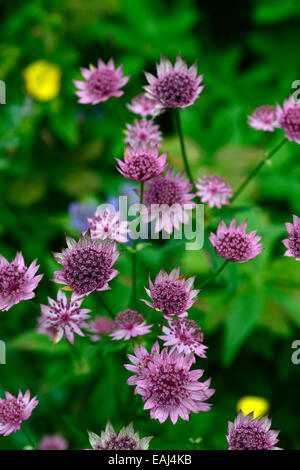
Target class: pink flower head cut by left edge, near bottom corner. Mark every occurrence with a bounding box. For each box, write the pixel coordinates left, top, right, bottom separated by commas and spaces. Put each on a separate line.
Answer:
0, 390, 38, 436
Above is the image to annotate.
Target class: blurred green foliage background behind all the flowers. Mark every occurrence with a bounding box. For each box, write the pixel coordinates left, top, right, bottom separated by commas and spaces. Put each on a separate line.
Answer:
0, 0, 300, 449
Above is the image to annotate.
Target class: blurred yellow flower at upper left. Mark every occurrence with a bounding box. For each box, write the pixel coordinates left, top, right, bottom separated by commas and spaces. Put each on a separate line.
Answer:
23, 60, 61, 101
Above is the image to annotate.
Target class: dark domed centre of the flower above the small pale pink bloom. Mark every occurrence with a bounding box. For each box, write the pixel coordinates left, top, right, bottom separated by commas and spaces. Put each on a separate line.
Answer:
151, 280, 188, 315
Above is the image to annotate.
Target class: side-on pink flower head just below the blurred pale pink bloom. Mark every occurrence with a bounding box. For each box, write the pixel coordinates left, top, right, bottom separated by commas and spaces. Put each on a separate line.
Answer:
116, 147, 168, 182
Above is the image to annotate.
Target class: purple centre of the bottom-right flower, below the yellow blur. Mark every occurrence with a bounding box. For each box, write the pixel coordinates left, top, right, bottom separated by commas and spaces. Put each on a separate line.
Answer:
230, 423, 271, 450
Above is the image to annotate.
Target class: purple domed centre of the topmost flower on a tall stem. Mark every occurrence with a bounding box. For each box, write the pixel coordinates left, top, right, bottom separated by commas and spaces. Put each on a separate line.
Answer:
153, 71, 197, 108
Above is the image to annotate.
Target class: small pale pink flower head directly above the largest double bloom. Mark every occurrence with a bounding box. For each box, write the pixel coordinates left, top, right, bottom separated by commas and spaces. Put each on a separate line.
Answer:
159, 318, 207, 357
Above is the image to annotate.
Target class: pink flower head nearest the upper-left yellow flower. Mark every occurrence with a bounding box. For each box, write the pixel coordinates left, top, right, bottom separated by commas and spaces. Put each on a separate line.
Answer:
73, 59, 129, 104
